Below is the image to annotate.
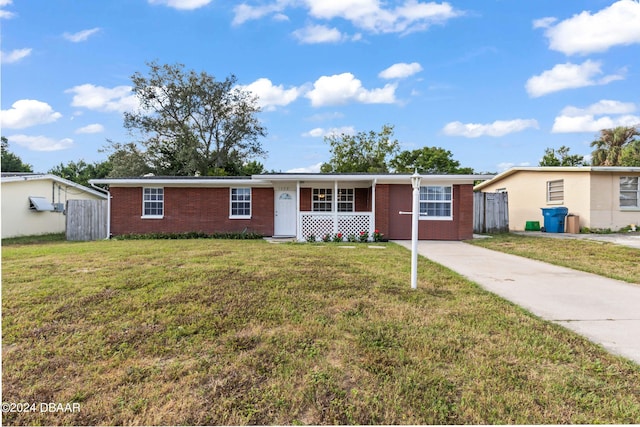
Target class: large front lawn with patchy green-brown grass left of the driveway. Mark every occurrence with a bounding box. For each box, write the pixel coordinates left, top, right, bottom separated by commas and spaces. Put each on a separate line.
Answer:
2, 240, 640, 425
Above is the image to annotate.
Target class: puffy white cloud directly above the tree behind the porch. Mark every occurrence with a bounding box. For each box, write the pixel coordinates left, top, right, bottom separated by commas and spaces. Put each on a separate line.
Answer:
305, 73, 397, 107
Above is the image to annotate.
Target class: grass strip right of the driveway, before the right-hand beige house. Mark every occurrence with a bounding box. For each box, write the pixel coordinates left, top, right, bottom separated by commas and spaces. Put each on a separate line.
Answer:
468, 234, 640, 284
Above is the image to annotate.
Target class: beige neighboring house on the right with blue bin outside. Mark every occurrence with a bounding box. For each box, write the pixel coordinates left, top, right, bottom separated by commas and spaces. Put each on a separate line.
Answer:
474, 166, 640, 231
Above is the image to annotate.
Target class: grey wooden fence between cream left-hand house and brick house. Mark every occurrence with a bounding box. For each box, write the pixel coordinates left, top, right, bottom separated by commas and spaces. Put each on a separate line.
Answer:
66, 200, 107, 240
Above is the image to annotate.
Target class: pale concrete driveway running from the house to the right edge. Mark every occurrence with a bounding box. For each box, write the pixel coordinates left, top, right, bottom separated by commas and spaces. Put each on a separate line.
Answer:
396, 240, 640, 364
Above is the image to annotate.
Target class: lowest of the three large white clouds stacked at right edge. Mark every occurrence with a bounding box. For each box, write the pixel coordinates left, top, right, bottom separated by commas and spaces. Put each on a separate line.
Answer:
551, 99, 640, 133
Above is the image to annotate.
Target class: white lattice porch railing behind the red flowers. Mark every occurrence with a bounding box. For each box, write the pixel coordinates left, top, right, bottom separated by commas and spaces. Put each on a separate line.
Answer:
298, 212, 375, 240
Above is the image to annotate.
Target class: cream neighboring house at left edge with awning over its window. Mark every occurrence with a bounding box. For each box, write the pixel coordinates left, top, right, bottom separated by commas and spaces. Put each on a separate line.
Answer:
1, 173, 106, 239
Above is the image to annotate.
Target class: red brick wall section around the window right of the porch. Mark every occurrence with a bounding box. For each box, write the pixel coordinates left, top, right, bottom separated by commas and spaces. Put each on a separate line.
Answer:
376, 184, 473, 240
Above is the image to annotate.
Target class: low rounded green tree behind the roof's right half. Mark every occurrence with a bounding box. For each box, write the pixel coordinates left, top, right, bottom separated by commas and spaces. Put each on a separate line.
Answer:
389, 147, 473, 174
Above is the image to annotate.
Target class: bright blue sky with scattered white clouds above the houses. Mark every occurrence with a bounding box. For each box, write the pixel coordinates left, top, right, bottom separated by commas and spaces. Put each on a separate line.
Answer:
0, 0, 640, 172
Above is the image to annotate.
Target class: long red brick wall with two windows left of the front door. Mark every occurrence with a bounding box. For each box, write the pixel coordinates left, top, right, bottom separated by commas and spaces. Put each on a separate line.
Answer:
111, 187, 274, 236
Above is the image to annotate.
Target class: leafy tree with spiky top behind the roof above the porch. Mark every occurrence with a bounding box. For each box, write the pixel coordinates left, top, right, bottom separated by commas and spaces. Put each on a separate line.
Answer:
320, 125, 400, 173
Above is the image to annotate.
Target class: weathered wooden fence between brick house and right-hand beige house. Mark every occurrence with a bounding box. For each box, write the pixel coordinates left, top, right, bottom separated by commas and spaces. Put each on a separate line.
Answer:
473, 192, 509, 233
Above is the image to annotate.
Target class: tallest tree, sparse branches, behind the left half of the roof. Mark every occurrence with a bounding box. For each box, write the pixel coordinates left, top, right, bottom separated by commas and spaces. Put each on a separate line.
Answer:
121, 62, 266, 175
